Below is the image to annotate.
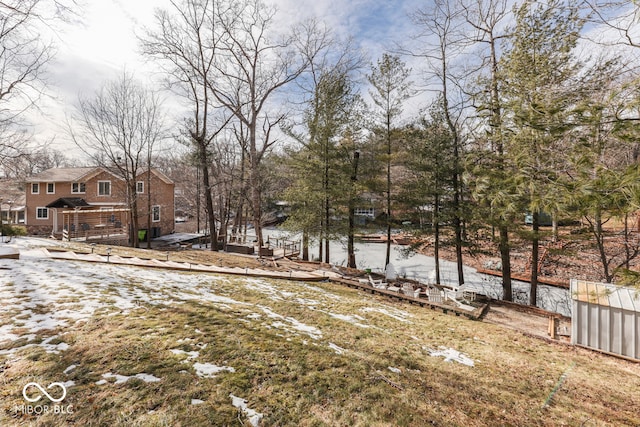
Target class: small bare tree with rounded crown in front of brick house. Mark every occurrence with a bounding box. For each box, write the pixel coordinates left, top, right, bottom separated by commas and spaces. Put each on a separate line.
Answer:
69, 73, 164, 247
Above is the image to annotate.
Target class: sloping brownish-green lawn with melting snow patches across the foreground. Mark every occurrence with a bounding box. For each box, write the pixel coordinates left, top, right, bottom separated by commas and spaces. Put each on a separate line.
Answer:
0, 249, 640, 426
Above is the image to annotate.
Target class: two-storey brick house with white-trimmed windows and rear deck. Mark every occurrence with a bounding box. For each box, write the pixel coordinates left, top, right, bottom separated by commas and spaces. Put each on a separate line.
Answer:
25, 167, 174, 238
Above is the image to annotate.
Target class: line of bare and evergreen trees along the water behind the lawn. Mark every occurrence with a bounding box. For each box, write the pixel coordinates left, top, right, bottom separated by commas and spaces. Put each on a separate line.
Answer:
0, 0, 640, 305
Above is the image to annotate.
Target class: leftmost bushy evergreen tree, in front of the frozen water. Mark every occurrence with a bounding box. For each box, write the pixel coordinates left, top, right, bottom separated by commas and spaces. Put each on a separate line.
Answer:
285, 67, 361, 262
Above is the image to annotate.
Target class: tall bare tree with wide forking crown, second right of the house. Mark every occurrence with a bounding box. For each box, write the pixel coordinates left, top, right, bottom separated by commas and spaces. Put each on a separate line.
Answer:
207, 0, 323, 247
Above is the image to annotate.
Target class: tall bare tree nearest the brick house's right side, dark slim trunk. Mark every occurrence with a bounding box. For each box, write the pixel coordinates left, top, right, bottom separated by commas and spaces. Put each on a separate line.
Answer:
141, 0, 229, 250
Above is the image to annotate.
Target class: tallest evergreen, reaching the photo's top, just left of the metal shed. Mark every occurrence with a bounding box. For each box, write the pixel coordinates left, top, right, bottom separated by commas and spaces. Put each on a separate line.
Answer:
502, 0, 583, 305
